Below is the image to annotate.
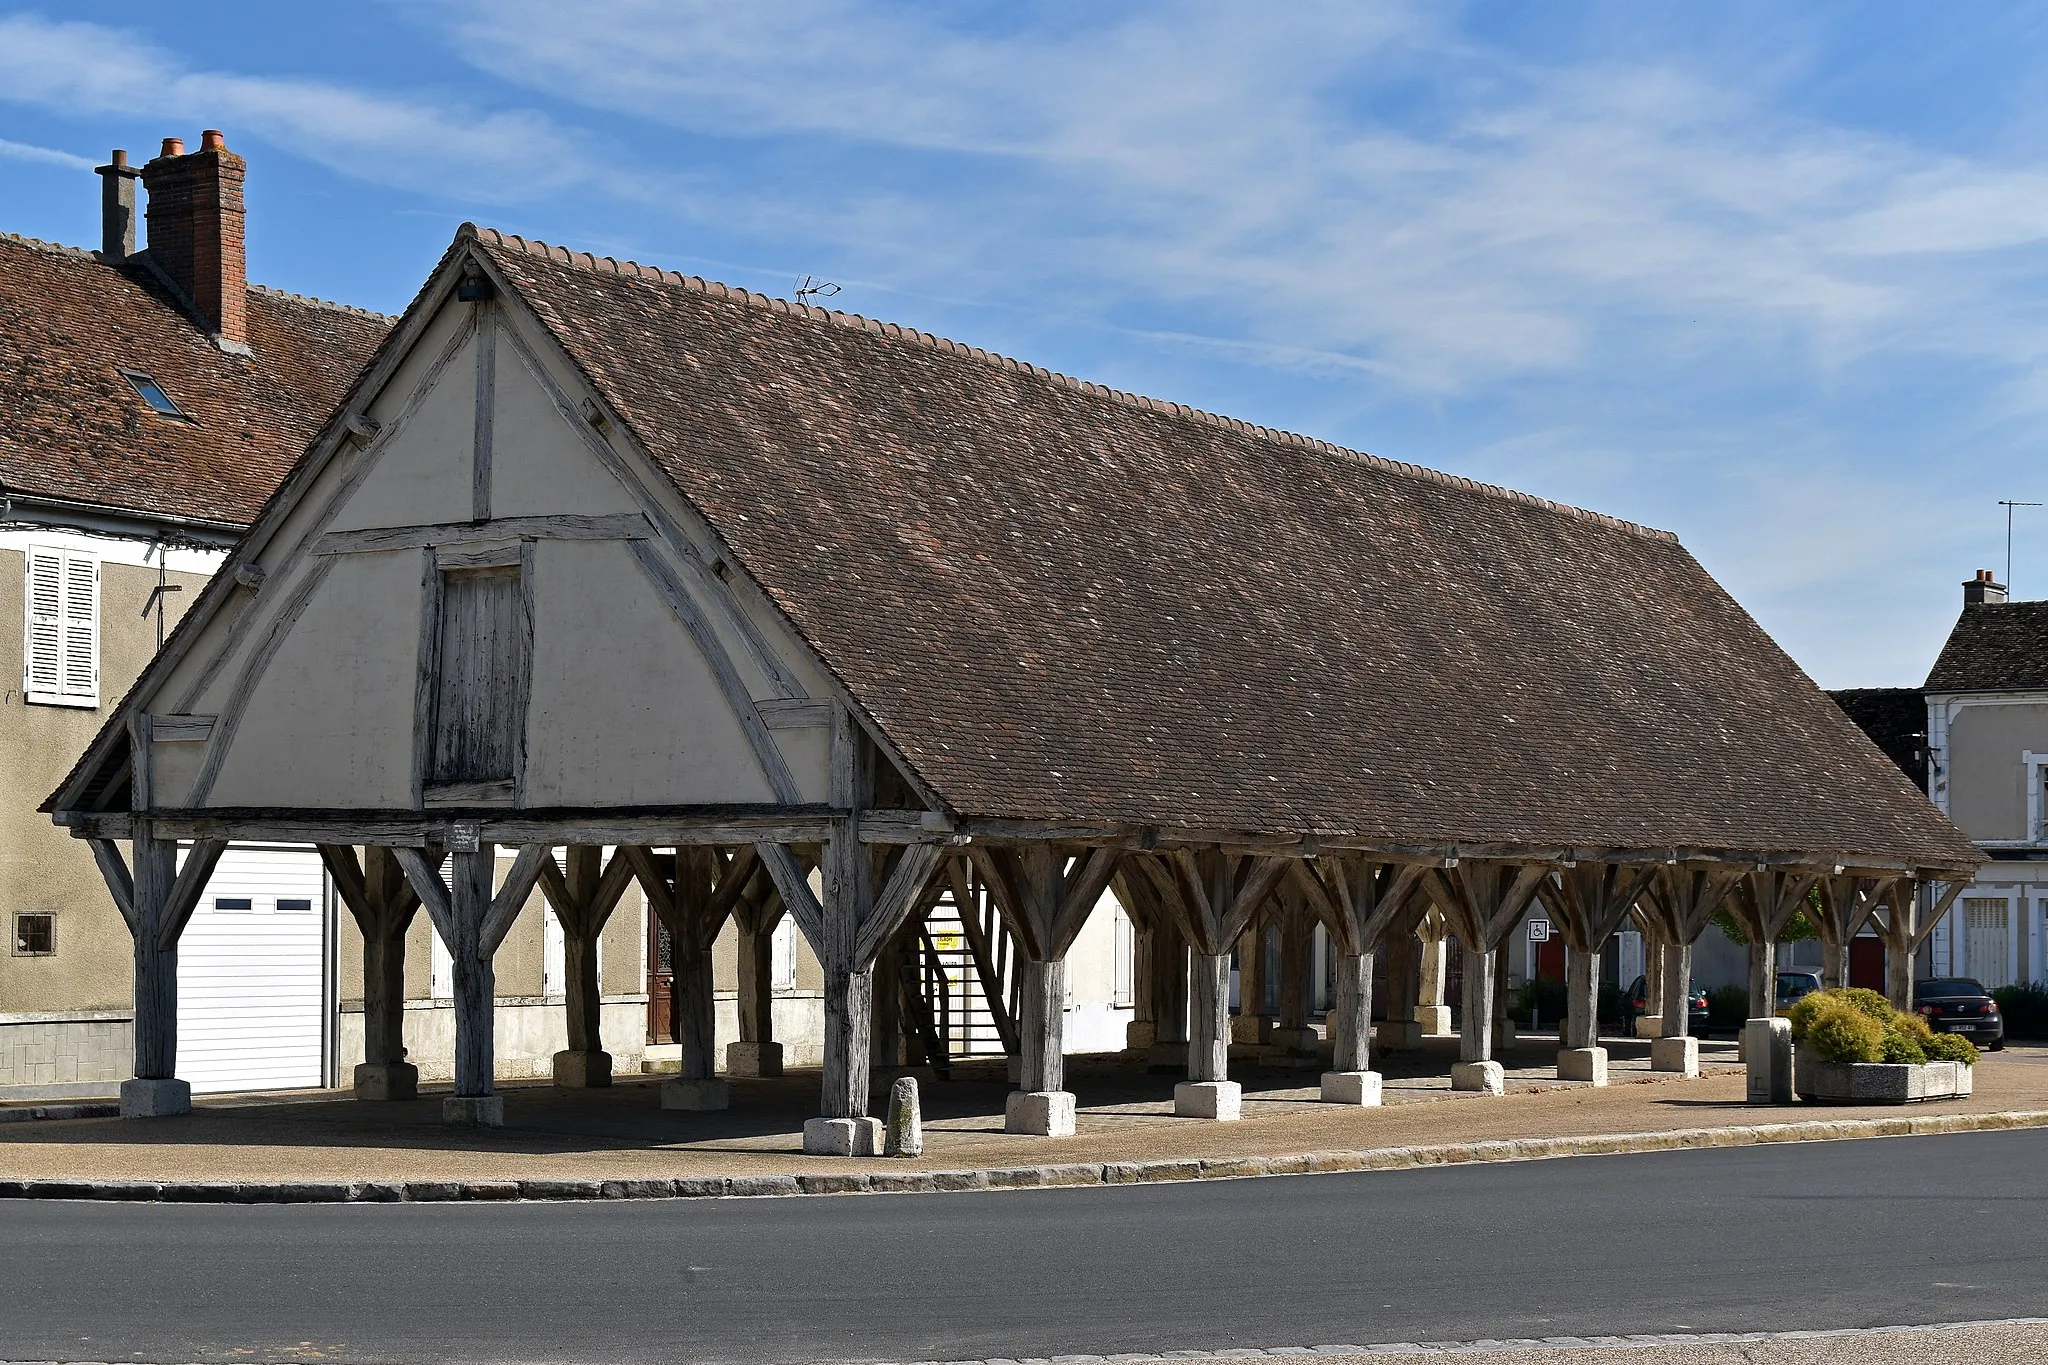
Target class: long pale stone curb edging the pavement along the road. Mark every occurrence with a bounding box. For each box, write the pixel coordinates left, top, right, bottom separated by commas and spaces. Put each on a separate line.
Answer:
0, 1109, 2048, 1203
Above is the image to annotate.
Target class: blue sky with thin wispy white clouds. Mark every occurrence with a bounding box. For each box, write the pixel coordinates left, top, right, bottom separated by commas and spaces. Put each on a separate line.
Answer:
0, 0, 2048, 686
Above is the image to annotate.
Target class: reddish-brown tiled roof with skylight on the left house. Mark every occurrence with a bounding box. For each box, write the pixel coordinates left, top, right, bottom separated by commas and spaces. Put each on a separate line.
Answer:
0, 235, 391, 526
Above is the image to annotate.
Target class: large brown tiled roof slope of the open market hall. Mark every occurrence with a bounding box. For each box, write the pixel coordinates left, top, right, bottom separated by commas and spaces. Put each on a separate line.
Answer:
465, 229, 1978, 866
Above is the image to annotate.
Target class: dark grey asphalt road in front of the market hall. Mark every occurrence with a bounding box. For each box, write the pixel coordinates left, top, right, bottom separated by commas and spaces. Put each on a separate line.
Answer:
0, 1130, 2048, 1365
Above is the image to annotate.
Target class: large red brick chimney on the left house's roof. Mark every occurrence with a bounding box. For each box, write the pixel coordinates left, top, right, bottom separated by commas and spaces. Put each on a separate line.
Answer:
141, 129, 248, 350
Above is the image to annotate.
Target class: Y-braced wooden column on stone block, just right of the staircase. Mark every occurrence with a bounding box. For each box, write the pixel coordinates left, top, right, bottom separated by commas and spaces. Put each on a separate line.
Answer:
967, 841, 1122, 1138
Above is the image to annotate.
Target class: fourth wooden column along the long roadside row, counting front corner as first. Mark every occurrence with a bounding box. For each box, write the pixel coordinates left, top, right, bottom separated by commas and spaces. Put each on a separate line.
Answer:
1294, 853, 1423, 1105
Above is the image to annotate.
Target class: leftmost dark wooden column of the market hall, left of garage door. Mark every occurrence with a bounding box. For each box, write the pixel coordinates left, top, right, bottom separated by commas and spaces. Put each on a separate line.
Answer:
92, 834, 227, 1119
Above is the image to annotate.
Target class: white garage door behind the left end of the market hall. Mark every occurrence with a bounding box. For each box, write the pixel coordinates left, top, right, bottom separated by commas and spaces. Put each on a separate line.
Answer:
178, 847, 328, 1093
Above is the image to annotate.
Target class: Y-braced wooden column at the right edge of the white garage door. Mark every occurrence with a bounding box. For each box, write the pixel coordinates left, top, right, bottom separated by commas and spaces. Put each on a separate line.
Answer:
319, 843, 423, 1101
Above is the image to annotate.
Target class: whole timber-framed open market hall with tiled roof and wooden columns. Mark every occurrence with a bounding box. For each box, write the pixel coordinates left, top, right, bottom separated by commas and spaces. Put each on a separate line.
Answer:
45, 225, 1980, 1154
